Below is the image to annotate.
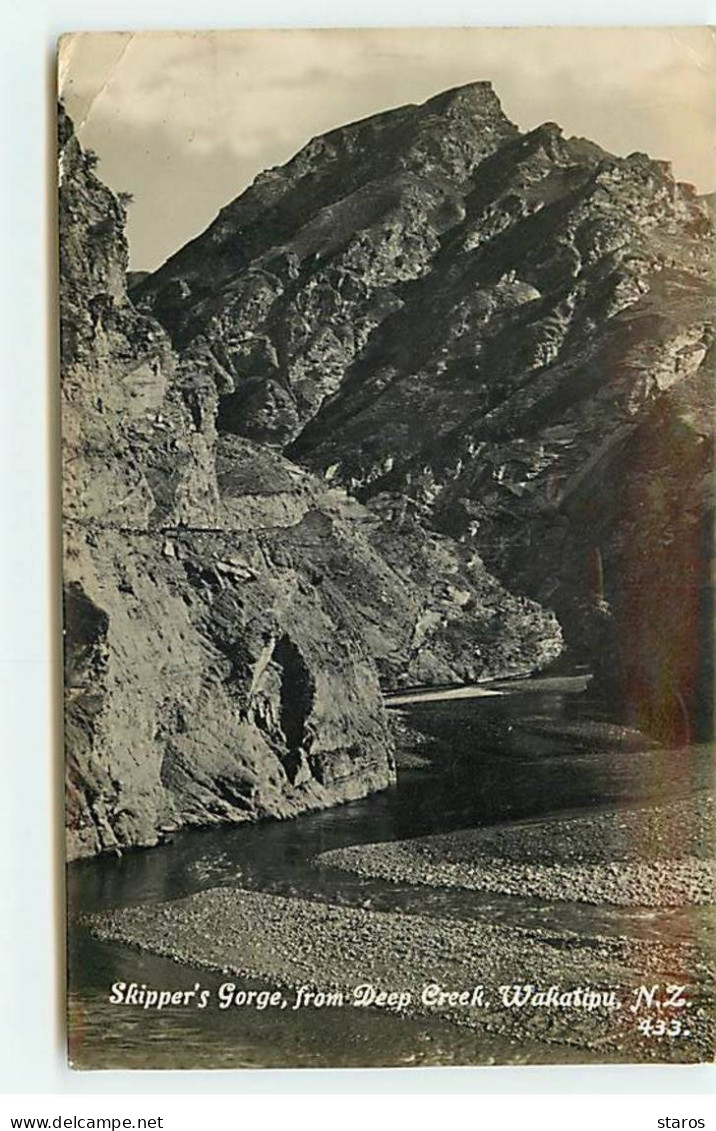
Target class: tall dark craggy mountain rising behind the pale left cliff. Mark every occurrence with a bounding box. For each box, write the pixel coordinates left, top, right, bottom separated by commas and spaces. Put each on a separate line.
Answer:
132, 84, 715, 742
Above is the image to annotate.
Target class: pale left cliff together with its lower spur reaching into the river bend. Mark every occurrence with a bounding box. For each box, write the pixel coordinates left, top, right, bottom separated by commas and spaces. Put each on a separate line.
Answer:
59, 101, 561, 857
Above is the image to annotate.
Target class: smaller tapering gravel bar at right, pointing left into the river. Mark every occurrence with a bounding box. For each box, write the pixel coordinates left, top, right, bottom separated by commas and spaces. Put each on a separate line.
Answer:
318, 795, 714, 907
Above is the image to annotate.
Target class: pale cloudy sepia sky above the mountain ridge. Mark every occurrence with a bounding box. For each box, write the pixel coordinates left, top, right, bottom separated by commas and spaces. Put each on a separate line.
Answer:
59, 27, 716, 270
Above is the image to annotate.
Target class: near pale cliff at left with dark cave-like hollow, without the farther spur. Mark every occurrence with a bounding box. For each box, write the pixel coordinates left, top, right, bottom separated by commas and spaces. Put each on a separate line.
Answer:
60, 113, 392, 855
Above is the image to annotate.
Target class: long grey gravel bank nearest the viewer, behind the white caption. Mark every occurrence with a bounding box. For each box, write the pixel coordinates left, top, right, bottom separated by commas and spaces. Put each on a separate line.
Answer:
85, 873, 713, 1063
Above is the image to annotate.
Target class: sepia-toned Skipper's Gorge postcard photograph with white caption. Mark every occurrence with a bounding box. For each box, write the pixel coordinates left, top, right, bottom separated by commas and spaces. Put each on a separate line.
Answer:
57, 26, 716, 1071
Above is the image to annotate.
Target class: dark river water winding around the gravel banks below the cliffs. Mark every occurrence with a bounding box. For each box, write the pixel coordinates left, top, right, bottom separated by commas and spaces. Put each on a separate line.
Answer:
68, 691, 709, 1067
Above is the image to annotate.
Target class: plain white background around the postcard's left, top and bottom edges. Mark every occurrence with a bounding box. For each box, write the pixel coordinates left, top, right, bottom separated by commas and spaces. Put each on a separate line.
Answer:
0, 0, 716, 1103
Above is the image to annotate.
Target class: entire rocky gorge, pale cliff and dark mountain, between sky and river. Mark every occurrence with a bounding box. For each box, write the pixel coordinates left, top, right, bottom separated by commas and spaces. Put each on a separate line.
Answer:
59, 83, 714, 856
